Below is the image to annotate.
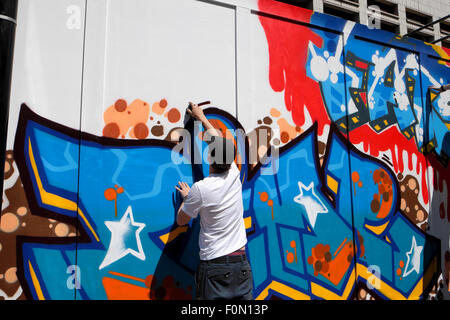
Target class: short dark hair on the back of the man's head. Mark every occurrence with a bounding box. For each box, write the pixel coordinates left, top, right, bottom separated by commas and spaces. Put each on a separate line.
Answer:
209, 136, 236, 173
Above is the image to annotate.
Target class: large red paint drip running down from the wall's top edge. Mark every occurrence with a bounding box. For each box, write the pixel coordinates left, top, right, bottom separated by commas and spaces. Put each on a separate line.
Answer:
258, 0, 330, 135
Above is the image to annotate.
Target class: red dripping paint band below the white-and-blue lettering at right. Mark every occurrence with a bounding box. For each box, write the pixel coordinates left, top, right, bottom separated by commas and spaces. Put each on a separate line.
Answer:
350, 124, 429, 204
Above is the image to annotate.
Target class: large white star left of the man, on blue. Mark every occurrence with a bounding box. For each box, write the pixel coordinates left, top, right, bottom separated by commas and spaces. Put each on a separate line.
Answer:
98, 206, 145, 270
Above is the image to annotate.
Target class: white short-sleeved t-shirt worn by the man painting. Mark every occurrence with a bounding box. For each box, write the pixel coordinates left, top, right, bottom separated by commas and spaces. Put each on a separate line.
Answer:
183, 162, 247, 260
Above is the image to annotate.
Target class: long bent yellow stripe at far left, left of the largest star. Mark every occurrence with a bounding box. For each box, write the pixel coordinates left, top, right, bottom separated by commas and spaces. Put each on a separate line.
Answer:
28, 138, 100, 242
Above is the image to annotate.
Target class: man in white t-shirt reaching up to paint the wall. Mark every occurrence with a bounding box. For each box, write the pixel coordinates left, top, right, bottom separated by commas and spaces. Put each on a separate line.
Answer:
175, 103, 253, 300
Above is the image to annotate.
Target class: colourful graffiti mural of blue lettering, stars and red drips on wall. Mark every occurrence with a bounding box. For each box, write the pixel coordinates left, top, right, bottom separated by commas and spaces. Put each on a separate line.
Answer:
0, 0, 450, 300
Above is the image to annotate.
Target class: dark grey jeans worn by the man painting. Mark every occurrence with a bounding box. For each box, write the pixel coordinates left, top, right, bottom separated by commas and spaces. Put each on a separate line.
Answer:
195, 255, 253, 300
